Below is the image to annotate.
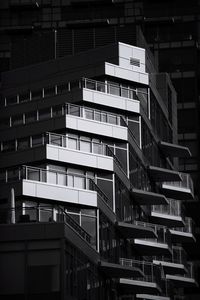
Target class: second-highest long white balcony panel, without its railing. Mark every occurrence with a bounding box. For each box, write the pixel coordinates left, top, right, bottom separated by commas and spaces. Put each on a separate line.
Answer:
83, 88, 140, 114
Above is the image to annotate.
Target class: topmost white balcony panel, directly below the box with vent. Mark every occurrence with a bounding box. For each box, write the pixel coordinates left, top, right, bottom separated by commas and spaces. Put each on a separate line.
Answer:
105, 62, 149, 85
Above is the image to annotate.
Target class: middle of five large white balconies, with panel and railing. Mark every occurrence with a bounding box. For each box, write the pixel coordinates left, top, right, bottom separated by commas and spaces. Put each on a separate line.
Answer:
65, 103, 128, 141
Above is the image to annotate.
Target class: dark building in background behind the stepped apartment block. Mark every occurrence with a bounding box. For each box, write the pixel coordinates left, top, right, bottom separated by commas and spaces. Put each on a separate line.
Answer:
0, 0, 200, 299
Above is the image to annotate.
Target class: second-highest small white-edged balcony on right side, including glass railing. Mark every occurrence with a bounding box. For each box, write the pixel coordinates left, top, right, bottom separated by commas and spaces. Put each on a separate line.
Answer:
150, 199, 185, 227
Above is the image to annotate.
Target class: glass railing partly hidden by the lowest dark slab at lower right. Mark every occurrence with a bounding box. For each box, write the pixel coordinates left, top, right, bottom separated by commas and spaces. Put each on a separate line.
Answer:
120, 258, 162, 286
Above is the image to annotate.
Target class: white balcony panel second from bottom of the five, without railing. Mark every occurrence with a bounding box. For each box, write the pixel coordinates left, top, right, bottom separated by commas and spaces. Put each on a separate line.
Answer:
46, 145, 114, 172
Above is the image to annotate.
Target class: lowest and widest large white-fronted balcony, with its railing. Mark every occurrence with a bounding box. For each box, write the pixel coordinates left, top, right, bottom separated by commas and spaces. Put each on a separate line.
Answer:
0, 166, 116, 223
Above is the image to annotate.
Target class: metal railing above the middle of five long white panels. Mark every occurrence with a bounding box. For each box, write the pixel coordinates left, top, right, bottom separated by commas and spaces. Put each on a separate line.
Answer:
65, 103, 124, 126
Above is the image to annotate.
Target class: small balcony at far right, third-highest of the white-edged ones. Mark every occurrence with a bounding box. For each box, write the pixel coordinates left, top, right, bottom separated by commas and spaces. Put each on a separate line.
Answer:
170, 217, 196, 244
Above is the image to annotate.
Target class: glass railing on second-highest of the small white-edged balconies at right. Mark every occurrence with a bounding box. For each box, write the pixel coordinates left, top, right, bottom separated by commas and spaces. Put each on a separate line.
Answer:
152, 199, 184, 218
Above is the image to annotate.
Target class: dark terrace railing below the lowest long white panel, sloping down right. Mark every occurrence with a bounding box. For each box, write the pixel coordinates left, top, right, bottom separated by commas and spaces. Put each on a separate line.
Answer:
0, 206, 92, 244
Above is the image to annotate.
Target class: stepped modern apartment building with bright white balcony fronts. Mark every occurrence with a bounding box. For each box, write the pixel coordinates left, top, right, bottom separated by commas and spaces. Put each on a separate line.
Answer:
0, 43, 198, 300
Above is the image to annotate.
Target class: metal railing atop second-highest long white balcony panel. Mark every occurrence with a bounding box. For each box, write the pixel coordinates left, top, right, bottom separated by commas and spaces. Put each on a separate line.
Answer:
82, 78, 147, 101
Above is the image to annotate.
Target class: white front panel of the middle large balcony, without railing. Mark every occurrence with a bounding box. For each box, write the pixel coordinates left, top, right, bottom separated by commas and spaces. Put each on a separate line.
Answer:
66, 115, 128, 141
